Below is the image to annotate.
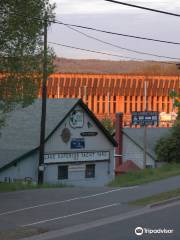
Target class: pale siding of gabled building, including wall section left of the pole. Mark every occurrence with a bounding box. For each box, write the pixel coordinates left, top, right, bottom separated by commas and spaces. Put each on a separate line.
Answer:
0, 106, 114, 186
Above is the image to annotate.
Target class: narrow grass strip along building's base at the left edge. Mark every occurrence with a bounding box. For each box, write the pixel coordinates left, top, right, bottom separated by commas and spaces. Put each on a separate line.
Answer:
0, 182, 66, 192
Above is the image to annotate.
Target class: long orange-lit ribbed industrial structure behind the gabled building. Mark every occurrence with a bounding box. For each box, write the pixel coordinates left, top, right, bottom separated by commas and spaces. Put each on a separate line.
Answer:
44, 73, 180, 126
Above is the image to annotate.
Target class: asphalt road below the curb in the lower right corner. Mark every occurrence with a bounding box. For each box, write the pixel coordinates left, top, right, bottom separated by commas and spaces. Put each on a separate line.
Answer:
51, 203, 180, 240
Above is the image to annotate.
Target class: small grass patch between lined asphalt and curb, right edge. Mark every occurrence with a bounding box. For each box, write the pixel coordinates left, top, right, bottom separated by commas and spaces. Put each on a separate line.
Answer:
129, 188, 180, 206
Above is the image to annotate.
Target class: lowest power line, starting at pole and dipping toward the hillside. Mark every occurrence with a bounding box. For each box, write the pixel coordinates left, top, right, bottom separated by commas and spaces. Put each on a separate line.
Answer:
48, 41, 176, 64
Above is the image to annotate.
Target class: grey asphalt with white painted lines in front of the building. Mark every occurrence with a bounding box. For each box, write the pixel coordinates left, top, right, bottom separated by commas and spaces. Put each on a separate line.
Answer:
0, 177, 180, 240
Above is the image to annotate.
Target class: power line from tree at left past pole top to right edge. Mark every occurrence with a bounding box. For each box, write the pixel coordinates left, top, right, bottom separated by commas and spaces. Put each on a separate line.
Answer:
0, 11, 180, 45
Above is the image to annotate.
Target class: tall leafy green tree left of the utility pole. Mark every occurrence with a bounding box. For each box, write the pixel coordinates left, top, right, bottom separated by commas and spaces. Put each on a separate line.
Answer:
0, 0, 55, 126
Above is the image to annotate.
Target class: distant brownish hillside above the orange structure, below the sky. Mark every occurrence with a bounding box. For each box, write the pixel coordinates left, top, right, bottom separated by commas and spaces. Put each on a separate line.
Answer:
55, 58, 178, 75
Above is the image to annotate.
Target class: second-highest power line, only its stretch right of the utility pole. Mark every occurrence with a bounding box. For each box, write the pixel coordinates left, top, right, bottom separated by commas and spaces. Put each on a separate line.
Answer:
57, 20, 180, 45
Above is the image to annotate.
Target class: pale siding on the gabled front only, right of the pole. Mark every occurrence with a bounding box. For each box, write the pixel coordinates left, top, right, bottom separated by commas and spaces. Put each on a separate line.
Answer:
45, 106, 114, 186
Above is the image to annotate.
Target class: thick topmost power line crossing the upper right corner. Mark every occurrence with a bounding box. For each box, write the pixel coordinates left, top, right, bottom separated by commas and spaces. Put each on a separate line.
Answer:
105, 0, 180, 17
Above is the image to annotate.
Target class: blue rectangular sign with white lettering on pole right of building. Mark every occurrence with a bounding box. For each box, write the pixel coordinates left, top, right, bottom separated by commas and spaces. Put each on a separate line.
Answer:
132, 112, 159, 125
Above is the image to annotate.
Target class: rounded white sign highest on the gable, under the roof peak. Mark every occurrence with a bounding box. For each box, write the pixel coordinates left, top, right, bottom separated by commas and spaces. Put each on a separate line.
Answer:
69, 110, 84, 128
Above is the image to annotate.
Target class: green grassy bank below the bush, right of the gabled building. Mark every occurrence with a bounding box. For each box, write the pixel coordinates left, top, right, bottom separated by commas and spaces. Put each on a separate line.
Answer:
108, 163, 180, 187
